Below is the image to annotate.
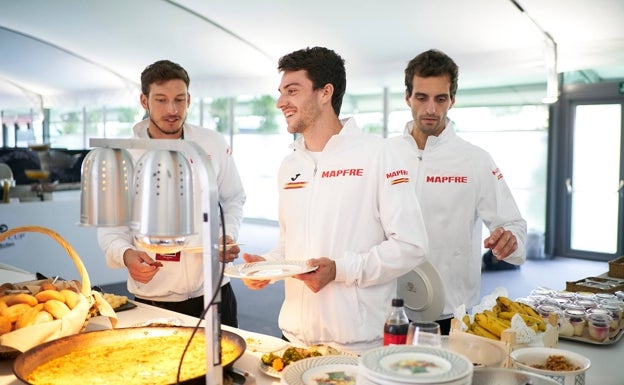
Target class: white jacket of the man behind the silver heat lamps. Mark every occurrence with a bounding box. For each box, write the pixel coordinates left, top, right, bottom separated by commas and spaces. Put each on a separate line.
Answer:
98, 120, 246, 302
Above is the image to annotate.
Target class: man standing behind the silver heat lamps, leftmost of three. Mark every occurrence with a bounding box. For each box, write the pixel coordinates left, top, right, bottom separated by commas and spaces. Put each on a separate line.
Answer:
98, 60, 245, 327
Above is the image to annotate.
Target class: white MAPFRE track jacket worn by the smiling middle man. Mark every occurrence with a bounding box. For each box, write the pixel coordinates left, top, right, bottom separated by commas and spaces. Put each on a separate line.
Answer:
264, 119, 427, 352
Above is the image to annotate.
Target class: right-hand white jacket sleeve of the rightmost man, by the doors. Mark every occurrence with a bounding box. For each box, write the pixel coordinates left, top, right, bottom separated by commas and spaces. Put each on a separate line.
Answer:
477, 154, 527, 265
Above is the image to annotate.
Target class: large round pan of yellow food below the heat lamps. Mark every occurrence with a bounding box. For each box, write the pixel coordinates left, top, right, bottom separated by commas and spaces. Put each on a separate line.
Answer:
13, 326, 246, 385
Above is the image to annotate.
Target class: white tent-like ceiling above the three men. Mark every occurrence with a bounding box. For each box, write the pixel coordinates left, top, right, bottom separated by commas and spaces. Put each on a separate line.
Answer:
0, 0, 624, 110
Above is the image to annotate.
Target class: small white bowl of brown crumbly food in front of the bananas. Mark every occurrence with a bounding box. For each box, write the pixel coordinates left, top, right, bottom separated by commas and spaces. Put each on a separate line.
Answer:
510, 347, 591, 385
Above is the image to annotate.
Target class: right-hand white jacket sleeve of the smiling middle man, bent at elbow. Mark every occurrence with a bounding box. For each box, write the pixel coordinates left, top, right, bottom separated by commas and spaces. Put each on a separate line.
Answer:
336, 145, 429, 287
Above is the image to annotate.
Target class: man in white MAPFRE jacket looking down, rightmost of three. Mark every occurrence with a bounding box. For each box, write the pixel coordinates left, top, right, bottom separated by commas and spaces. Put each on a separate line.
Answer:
388, 50, 526, 334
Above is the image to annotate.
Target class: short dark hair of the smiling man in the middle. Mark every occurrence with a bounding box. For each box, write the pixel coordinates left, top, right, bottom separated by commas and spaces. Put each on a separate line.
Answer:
277, 47, 347, 115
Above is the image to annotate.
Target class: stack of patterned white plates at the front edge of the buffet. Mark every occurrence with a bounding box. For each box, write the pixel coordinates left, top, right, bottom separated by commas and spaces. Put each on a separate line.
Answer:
357, 345, 473, 385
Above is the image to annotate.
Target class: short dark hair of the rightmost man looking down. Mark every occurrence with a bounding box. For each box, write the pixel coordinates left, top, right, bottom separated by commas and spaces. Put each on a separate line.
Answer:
405, 49, 459, 98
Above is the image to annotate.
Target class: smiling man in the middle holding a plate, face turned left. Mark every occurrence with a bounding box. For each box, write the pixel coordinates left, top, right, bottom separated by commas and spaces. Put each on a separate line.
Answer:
243, 47, 427, 353
